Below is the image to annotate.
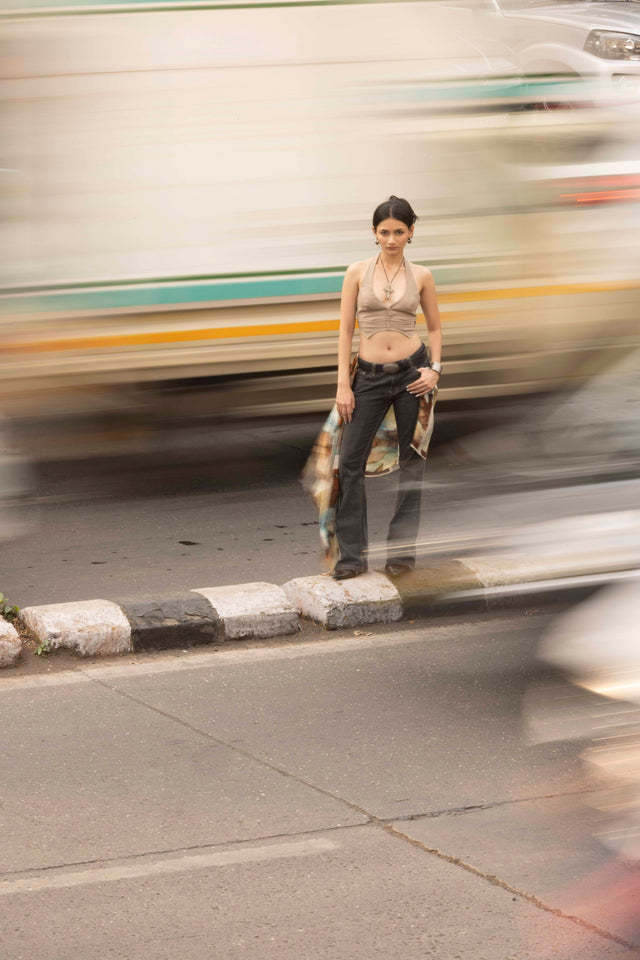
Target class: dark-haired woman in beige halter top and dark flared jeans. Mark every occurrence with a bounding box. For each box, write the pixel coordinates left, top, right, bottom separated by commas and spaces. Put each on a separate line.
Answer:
333, 196, 442, 580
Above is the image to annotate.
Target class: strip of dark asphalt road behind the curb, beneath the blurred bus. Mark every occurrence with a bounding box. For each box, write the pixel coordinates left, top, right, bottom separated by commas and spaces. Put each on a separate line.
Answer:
0, 410, 638, 607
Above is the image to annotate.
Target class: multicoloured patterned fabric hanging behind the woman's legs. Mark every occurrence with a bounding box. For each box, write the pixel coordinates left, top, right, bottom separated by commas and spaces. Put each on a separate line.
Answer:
300, 388, 438, 570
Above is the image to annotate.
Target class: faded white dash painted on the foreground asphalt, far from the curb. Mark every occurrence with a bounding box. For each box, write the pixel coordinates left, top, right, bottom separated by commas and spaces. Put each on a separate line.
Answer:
0, 837, 339, 896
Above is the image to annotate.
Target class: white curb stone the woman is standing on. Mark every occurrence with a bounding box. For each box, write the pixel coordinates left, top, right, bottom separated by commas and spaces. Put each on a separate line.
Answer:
283, 573, 402, 630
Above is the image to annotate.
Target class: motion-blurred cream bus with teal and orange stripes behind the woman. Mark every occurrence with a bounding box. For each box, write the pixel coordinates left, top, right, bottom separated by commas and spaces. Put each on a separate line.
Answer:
0, 0, 640, 454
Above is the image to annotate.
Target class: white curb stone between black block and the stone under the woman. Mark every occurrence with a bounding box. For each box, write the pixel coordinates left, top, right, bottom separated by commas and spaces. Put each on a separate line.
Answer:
192, 582, 298, 640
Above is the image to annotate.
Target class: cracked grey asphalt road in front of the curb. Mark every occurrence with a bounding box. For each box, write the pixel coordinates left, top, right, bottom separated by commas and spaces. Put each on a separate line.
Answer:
0, 616, 640, 960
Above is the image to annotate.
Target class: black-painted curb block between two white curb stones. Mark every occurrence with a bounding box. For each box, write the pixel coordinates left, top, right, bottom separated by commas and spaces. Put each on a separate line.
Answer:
114, 592, 224, 650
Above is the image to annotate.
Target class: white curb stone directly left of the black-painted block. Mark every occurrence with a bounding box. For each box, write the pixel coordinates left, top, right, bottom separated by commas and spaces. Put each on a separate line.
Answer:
20, 600, 132, 657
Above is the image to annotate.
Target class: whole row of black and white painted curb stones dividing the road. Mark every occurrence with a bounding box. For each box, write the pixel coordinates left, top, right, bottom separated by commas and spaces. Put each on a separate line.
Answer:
5, 554, 637, 668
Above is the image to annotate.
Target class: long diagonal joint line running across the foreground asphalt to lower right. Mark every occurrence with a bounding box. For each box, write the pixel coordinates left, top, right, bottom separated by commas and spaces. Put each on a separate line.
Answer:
86, 674, 640, 955
